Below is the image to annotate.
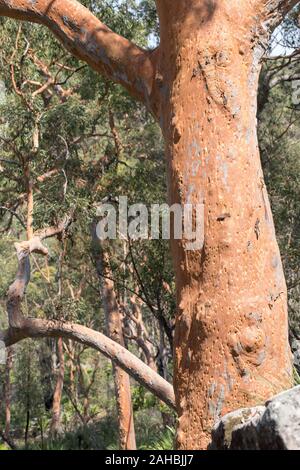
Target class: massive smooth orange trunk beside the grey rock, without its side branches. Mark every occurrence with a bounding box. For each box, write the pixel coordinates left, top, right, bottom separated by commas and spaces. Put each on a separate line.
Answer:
157, 0, 292, 449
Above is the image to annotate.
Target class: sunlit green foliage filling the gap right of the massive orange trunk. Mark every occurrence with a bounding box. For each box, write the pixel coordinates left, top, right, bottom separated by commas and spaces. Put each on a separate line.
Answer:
258, 47, 300, 331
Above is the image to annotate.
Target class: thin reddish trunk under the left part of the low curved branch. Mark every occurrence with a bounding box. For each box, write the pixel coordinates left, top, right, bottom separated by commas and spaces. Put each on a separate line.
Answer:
50, 338, 65, 437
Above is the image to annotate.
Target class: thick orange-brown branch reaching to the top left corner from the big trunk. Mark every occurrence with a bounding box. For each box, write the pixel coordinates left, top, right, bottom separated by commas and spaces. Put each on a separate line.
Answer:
0, 0, 158, 108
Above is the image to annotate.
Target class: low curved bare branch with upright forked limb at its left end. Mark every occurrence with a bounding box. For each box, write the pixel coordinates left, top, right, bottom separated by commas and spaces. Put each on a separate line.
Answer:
0, 231, 175, 409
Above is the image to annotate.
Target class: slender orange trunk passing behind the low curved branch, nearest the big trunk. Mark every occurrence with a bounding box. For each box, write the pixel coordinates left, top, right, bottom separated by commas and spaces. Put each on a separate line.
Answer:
99, 250, 136, 450
